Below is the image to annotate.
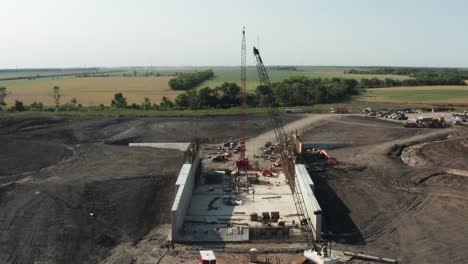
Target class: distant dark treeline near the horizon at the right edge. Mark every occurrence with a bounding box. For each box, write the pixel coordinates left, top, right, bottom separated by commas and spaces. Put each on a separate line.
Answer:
345, 68, 468, 88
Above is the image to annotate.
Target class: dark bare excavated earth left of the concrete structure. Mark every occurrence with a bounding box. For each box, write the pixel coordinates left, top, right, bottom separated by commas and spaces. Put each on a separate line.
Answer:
0, 116, 298, 264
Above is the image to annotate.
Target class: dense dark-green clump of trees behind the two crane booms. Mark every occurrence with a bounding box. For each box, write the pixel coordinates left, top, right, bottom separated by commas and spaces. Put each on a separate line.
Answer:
173, 77, 359, 109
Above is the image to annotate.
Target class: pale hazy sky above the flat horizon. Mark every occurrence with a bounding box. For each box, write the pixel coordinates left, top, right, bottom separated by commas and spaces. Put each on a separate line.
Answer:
0, 0, 468, 69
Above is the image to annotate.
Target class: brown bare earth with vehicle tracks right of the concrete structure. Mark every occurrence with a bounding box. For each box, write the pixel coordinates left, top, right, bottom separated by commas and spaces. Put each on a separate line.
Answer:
303, 116, 468, 263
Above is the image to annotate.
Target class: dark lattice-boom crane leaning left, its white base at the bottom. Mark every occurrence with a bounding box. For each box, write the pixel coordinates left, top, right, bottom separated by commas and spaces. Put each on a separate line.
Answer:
253, 47, 336, 264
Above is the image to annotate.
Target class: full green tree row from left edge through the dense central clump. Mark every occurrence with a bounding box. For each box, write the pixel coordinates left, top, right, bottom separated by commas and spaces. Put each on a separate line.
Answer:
0, 77, 360, 112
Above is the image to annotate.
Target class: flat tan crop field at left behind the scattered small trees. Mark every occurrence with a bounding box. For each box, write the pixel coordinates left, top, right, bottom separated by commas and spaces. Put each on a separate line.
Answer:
0, 76, 181, 105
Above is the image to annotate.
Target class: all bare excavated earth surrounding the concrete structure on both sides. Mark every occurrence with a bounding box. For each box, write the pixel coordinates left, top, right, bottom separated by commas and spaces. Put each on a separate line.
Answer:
0, 115, 468, 263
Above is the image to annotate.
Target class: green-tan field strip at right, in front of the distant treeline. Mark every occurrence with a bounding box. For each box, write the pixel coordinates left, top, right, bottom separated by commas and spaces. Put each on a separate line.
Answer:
356, 86, 468, 105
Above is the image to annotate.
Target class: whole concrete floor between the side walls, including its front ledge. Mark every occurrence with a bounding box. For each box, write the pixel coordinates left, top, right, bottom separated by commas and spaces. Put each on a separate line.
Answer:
177, 171, 302, 242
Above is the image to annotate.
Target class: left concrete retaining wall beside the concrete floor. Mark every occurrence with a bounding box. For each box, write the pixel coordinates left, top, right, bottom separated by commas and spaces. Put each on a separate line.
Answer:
171, 152, 200, 241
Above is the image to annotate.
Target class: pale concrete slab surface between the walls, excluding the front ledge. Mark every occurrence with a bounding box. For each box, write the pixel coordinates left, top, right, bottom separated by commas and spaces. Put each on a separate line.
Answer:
185, 174, 299, 227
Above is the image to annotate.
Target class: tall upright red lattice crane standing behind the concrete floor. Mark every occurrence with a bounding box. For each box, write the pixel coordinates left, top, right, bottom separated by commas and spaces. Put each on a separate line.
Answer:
236, 28, 249, 170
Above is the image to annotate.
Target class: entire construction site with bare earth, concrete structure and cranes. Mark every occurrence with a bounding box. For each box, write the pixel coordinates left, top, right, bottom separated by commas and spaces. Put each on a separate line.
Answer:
0, 28, 468, 264
